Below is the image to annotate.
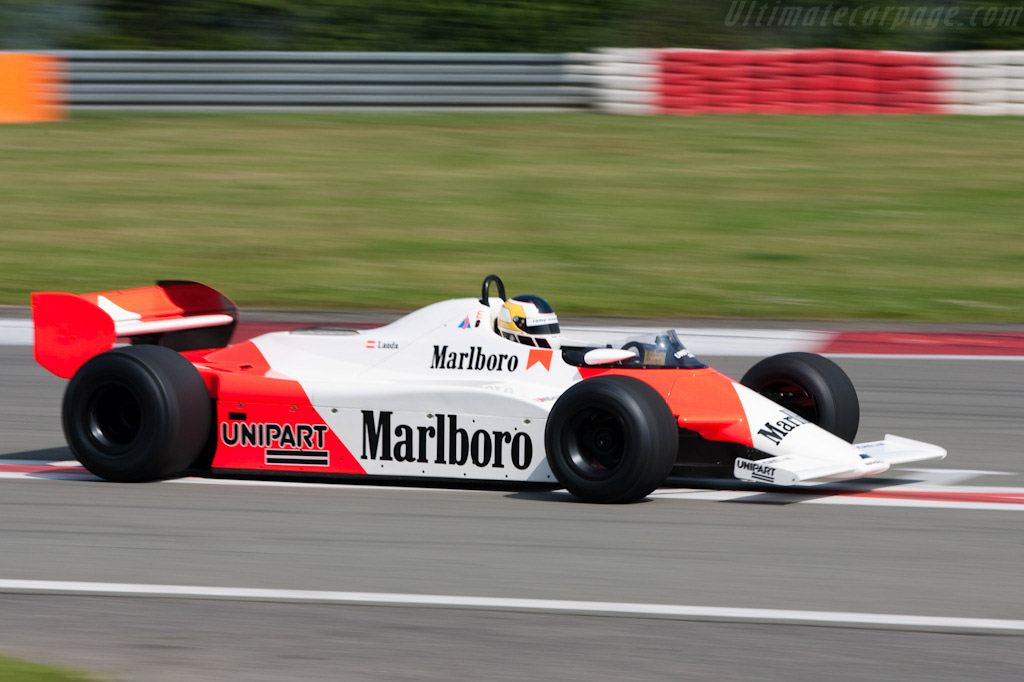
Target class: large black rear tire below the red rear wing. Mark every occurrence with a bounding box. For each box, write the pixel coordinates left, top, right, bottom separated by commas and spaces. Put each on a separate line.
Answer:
62, 345, 213, 481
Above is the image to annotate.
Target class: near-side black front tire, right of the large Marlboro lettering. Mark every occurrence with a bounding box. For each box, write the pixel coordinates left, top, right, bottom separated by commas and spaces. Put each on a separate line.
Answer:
545, 376, 679, 504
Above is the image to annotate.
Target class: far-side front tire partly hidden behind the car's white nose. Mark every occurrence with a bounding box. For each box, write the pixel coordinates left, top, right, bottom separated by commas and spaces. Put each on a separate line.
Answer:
739, 353, 860, 442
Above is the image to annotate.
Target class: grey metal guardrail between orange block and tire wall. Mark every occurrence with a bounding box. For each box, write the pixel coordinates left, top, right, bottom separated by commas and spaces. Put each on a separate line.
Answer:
54, 50, 593, 112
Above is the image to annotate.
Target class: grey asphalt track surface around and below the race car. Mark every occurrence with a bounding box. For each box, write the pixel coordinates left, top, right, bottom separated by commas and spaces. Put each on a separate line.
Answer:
0, 346, 1024, 682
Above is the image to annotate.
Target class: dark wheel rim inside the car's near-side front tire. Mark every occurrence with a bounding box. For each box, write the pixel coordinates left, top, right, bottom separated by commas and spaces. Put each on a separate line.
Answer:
563, 408, 627, 480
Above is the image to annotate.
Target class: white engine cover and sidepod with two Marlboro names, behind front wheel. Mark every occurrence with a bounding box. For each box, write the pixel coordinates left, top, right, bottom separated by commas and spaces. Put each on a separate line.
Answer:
247, 298, 581, 482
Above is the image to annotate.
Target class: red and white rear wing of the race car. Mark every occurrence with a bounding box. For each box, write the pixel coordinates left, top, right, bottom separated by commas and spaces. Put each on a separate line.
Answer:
32, 282, 239, 379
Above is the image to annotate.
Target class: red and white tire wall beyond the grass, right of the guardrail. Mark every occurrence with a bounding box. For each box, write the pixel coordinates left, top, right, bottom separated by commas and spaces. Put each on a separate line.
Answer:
585, 49, 1024, 115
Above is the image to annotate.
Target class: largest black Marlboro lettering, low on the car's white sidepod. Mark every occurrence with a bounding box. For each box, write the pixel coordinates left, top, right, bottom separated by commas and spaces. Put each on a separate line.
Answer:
361, 410, 534, 470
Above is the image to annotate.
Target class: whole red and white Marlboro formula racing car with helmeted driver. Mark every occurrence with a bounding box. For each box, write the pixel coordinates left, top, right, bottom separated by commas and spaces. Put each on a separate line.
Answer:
32, 275, 945, 503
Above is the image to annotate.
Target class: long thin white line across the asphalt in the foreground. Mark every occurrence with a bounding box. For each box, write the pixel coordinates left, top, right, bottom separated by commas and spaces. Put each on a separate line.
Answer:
0, 580, 1024, 632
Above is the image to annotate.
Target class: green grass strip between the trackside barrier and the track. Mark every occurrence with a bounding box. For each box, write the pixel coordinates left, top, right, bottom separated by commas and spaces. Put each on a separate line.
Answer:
0, 114, 1024, 321
